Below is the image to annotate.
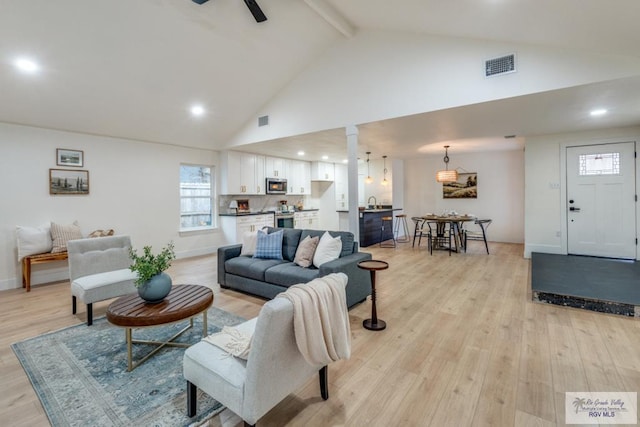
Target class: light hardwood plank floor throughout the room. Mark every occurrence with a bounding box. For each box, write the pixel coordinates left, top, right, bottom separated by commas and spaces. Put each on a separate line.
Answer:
0, 242, 640, 427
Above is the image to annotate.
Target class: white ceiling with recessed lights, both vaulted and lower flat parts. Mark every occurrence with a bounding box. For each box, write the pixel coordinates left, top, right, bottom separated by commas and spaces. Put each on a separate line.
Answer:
0, 0, 640, 159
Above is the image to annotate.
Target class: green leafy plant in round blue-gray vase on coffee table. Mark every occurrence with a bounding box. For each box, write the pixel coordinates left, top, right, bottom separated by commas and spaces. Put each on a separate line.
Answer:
129, 242, 176, 303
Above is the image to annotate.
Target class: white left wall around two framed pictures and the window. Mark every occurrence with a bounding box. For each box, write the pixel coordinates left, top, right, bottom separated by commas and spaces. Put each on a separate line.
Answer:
0, 123, 222, 289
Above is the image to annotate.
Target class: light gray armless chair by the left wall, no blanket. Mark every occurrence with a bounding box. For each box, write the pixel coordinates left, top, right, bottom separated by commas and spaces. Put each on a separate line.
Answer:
67, 236, 137, 325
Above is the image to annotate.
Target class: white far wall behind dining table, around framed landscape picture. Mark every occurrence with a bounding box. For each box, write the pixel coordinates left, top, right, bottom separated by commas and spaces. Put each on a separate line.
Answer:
404, 150, 525, 243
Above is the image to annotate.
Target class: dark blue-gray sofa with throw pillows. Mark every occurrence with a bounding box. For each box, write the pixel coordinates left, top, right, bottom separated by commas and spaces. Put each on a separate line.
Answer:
218, 227, 371, 308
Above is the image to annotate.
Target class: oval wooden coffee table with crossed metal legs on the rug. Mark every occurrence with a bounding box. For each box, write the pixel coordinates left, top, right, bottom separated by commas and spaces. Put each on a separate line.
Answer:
107, 285, 213, 371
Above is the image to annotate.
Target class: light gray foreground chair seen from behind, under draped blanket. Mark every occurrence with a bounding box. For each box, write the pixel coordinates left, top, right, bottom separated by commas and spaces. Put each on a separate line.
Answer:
183, 298, 329, 425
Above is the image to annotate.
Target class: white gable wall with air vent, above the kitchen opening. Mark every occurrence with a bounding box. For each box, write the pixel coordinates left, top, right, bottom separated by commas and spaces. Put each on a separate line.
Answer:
229, 30, 640, 147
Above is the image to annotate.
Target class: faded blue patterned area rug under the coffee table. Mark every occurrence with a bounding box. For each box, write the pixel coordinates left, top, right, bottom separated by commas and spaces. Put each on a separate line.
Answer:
11, 307, 244, 427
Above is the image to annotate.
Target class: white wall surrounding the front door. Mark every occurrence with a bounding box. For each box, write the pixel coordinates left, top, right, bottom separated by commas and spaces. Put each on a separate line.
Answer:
525, 123, 640, 257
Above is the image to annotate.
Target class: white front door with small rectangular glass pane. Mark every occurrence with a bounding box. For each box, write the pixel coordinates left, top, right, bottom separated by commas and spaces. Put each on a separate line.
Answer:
566, 142, 636, 259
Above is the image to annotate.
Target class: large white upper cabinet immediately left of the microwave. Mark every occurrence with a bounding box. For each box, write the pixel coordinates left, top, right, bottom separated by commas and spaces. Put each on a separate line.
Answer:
220, 151, 265, 195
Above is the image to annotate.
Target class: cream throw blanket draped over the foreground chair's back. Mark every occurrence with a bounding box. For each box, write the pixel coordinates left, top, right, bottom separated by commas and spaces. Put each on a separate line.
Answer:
278, 273, 351, 366
